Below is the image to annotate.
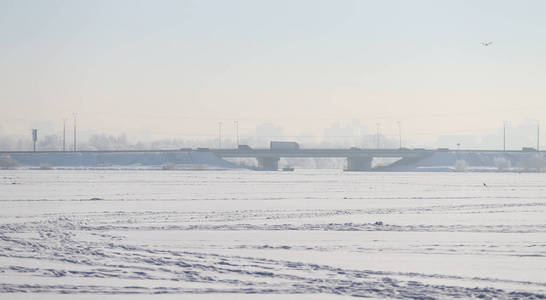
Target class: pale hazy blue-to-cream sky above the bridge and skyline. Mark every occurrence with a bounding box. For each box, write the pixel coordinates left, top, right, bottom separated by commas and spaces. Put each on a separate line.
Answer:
0, 0, 546, 146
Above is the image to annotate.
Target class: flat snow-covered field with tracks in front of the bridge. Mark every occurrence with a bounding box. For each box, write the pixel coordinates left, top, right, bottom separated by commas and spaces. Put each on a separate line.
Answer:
0, 170, 546, 299
